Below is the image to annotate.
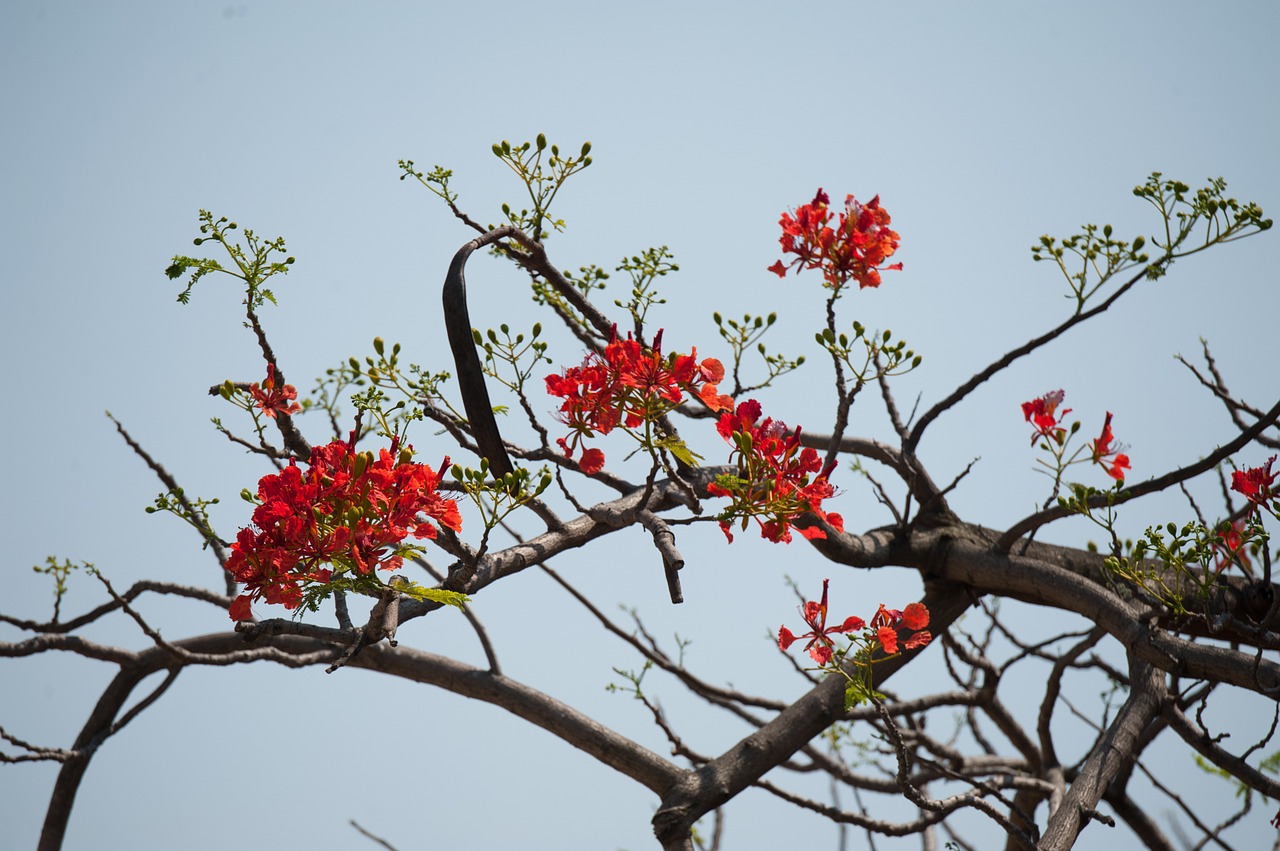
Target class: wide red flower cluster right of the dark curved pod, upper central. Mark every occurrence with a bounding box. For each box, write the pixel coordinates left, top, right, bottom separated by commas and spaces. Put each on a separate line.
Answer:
547, 328, 733, 473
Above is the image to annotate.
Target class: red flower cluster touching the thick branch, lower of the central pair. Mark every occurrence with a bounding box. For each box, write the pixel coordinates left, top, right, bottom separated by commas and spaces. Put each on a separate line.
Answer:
707, 399, 845, 544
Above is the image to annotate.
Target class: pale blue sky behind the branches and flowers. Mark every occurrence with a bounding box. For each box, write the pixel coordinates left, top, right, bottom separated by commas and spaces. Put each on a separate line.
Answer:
0, 0, 1280, 851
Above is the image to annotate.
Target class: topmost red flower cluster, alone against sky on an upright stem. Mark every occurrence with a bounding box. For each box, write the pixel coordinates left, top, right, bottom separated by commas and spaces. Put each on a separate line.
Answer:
769, 189, 902, 290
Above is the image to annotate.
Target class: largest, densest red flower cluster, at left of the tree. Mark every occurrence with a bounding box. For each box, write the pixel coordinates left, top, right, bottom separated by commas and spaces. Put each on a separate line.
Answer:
227, 435, 462, 621
